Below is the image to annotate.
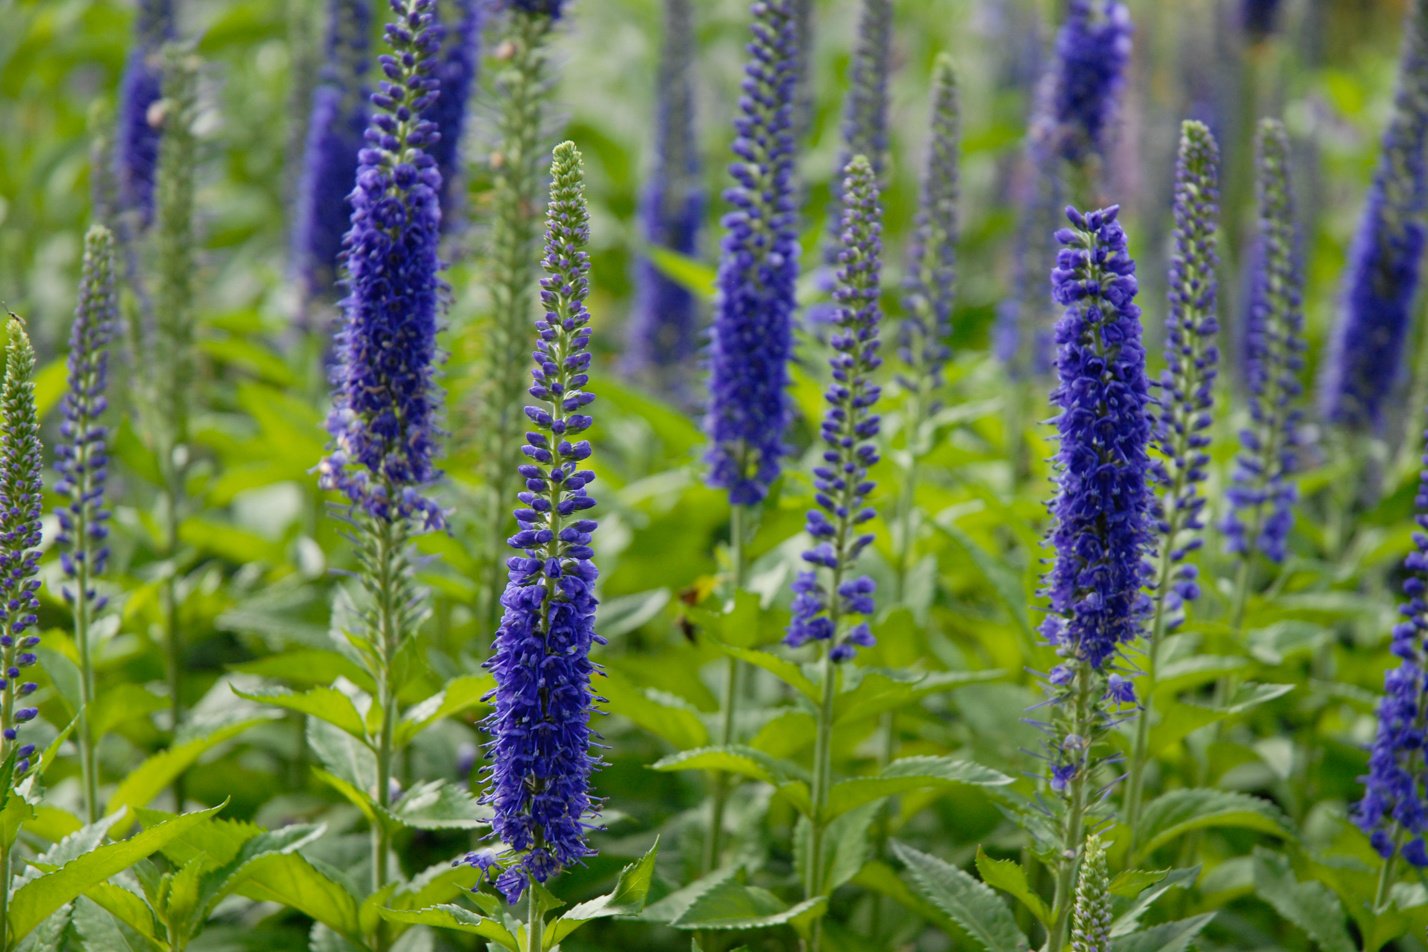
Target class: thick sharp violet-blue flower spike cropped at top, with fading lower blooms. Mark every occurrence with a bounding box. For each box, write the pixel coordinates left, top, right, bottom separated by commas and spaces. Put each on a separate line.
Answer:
320, 0, 443, 525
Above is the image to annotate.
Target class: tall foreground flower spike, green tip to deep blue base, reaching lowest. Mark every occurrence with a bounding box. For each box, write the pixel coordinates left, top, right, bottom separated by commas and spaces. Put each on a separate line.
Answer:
484, 143, 604, 903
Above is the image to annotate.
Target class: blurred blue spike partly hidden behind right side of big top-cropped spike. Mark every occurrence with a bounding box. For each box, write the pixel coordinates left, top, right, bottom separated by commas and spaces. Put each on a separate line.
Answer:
423, 0, 486, 228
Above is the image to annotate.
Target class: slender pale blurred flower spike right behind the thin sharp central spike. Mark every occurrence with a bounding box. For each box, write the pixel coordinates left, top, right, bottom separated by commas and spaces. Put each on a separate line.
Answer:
900, 54, 961, 390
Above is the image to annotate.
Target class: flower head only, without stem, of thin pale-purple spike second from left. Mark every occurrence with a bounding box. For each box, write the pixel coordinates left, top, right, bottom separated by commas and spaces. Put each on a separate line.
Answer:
54, 226, 119, 605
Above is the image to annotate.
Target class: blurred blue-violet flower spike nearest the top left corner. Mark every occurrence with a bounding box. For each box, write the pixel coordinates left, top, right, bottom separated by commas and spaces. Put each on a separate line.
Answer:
114, 0, 176, 227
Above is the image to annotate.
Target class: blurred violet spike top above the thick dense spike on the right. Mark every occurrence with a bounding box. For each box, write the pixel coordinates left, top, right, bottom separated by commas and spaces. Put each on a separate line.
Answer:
1051, 0, 1131, 164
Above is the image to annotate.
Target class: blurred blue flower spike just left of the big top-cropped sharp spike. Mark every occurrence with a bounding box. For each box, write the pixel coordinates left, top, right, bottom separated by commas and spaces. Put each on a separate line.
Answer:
293, 0, 371, 309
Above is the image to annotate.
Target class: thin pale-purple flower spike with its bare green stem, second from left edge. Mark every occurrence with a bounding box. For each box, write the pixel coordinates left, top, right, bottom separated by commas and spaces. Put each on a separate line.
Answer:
54, 226, 119, 824
